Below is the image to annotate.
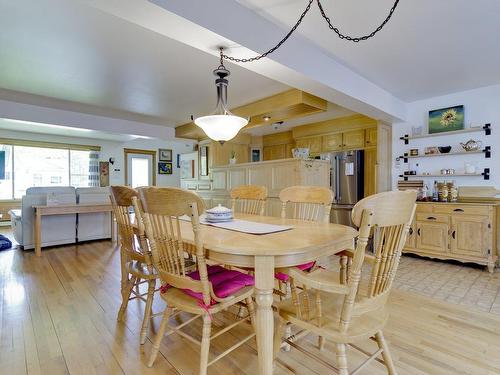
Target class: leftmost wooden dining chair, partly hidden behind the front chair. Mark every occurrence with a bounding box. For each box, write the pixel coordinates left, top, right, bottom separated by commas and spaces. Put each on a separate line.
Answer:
110, 186, 158, 345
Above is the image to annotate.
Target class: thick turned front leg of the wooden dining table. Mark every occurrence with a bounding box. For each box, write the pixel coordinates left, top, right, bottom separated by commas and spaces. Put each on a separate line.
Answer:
255, 256, 274, 375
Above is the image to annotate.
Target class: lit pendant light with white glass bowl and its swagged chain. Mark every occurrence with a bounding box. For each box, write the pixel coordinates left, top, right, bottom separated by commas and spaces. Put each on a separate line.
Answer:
191, 0, 400, 144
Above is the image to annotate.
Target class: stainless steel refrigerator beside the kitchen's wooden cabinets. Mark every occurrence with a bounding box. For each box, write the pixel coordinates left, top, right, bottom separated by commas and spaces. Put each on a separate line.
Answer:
321, 150, 364, 226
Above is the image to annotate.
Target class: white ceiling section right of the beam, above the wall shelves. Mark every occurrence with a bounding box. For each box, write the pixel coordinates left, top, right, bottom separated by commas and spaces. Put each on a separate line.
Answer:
237, 0, 500, 102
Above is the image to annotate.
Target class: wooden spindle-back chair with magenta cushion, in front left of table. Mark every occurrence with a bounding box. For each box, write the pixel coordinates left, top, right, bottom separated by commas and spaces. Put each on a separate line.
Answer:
138, 187, 255, 375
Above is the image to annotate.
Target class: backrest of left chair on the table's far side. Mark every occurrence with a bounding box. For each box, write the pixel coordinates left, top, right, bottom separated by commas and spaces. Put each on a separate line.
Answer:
231, 185, 267, 216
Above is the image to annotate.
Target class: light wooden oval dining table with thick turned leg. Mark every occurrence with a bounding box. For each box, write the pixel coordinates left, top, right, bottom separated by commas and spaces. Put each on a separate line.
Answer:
181, 214, 357, 375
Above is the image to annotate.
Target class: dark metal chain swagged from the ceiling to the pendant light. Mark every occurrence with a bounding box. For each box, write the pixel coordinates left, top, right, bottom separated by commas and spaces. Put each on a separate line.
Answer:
220, 0, 399, 65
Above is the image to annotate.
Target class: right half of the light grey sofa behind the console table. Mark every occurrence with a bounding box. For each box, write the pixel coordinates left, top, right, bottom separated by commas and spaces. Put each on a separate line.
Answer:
76, 187, 111, 242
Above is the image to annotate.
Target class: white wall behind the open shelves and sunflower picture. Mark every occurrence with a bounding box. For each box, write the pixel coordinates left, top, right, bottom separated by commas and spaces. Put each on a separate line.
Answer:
392, 85, 500, 188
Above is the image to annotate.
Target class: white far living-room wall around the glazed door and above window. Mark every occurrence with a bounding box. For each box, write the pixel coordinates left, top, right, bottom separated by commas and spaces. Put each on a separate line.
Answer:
0, 130, 194, 187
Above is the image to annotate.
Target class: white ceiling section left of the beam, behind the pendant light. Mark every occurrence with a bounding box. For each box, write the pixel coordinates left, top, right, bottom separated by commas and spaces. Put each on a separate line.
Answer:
0, 0, 288, 126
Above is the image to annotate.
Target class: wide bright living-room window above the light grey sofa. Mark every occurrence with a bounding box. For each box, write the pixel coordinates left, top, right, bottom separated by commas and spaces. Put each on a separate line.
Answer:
0, 144, 96, 200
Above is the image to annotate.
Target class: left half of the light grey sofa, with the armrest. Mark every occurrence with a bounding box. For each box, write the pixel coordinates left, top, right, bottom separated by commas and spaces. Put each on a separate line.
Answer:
9, 186, 76, 250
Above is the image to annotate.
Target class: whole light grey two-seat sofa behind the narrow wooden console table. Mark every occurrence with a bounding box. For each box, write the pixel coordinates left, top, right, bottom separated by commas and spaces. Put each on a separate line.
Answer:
9, 186, 111, 250
